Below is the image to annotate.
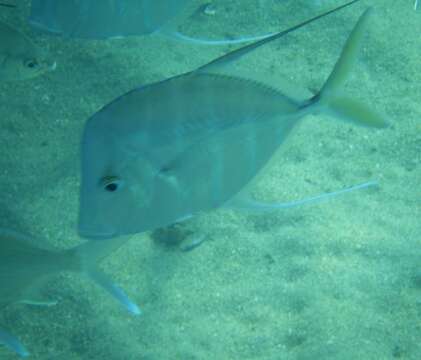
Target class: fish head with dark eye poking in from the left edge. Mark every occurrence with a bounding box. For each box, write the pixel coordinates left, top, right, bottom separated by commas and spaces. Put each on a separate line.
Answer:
0, 22, 56, 82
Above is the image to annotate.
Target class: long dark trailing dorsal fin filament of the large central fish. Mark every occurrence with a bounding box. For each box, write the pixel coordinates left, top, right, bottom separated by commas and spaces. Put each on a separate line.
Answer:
196, 0, 360, 72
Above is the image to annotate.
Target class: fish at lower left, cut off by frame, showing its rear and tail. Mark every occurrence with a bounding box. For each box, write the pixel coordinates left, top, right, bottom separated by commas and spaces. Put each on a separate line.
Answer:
0, 230, 140, 357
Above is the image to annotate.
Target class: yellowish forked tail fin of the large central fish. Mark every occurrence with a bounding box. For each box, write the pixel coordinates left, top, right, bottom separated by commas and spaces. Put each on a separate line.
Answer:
309, 8, 387, 128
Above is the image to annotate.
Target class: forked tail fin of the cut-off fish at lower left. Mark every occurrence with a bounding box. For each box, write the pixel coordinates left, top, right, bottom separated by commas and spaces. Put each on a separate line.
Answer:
66, 236, 141, 315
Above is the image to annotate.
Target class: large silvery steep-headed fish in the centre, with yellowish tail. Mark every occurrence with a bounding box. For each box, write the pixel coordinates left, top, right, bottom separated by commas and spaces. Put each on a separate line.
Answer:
79, 1, 386, 239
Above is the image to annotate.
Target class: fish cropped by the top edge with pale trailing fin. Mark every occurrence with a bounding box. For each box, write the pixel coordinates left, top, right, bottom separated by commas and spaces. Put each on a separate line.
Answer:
29, 0, 274, 45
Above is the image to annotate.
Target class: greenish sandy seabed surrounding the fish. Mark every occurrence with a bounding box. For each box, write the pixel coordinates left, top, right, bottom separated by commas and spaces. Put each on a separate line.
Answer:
0, 0, 421, 360
